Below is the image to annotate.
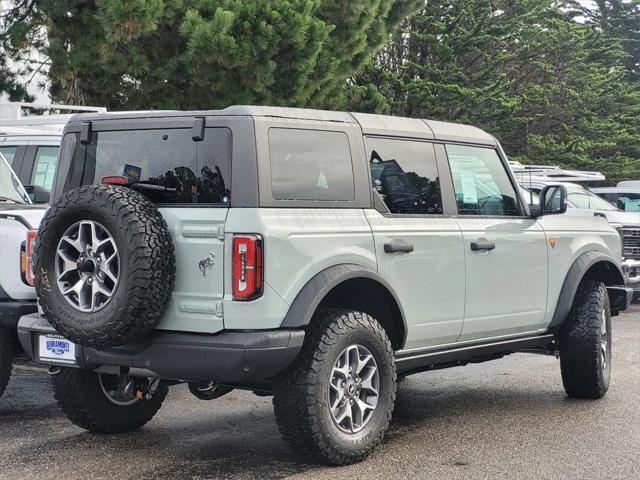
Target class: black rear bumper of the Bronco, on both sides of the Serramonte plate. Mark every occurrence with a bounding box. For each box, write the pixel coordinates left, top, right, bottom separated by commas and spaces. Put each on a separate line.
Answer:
18, 314, 304, 385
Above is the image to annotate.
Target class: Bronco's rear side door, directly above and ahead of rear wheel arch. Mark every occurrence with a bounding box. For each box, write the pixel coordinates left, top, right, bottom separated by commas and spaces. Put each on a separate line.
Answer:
365, 137, 465, 348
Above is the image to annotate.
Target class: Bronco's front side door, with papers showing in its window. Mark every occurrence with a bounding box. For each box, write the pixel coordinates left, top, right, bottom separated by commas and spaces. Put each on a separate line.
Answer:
446, 145, 547, 341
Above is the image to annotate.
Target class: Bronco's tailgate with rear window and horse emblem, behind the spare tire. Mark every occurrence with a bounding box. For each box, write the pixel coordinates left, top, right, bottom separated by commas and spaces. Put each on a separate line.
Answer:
61, 119, 232, 333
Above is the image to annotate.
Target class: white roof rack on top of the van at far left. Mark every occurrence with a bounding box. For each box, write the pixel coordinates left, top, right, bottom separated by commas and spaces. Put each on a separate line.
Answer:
0, 102, 107, 125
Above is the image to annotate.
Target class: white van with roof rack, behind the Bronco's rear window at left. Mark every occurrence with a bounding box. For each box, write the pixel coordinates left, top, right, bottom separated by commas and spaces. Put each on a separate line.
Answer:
0, 102, 106, 199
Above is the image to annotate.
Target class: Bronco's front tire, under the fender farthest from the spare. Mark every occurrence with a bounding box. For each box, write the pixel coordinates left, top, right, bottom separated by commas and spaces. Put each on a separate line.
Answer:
560, 280, 611, 399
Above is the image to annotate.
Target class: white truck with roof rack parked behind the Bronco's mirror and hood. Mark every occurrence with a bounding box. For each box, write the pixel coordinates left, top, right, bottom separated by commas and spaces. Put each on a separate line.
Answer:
520, 178, 640, 297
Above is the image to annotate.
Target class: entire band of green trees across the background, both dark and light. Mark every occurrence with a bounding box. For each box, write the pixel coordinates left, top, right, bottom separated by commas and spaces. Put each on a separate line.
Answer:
0, 0, 640, 182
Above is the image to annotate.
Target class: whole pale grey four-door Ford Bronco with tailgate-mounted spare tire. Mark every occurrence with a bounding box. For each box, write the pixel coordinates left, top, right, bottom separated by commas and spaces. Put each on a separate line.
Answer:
18, 106, 629, 464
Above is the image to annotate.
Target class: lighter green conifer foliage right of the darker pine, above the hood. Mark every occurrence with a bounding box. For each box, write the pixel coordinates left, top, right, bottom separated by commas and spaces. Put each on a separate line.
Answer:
357, 0, 640, 182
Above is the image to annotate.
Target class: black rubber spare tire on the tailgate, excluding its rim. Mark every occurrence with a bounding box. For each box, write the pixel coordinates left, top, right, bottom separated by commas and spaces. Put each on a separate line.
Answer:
35, 185, 175, 348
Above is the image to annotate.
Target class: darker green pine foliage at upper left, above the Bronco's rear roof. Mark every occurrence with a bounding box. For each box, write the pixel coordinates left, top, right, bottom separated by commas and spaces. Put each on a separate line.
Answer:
2, 0, 422, 109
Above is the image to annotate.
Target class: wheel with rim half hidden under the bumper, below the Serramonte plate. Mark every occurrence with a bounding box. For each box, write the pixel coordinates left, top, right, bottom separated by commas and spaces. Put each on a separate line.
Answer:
53, 368, 168, 433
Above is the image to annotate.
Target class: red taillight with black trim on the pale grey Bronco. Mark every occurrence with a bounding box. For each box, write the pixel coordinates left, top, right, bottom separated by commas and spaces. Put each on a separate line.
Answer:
231, 234, 262, 300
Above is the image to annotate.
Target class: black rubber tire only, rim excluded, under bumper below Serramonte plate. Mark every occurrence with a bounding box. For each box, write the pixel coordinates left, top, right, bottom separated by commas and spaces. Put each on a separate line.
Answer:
52, 368, 168, 433
